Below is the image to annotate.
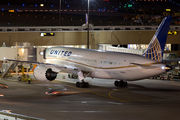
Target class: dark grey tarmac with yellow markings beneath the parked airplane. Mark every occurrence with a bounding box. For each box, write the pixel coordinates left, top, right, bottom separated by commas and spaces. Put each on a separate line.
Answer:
0, 73, 180, 120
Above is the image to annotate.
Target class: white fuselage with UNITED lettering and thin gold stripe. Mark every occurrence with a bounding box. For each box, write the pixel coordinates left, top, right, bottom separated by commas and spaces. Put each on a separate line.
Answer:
45, 47, 165, 81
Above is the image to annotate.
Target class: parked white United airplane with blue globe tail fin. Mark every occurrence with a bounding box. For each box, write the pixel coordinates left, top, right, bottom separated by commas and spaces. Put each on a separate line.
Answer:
6, 16, 172, 88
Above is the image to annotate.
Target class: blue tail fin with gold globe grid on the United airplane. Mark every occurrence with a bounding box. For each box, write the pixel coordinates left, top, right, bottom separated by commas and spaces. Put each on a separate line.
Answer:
143, 16, 172, 62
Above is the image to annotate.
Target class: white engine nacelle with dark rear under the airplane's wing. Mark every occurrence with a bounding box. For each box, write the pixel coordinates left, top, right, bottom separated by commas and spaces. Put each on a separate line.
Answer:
33, 65, 57, 81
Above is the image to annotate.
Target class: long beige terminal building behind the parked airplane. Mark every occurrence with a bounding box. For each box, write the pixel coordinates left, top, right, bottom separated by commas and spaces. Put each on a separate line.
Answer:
0, 26, 180, 62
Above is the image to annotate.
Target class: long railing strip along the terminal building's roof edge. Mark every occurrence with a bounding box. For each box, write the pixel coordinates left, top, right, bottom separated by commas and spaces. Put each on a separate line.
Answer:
0, 26, 180, 32
